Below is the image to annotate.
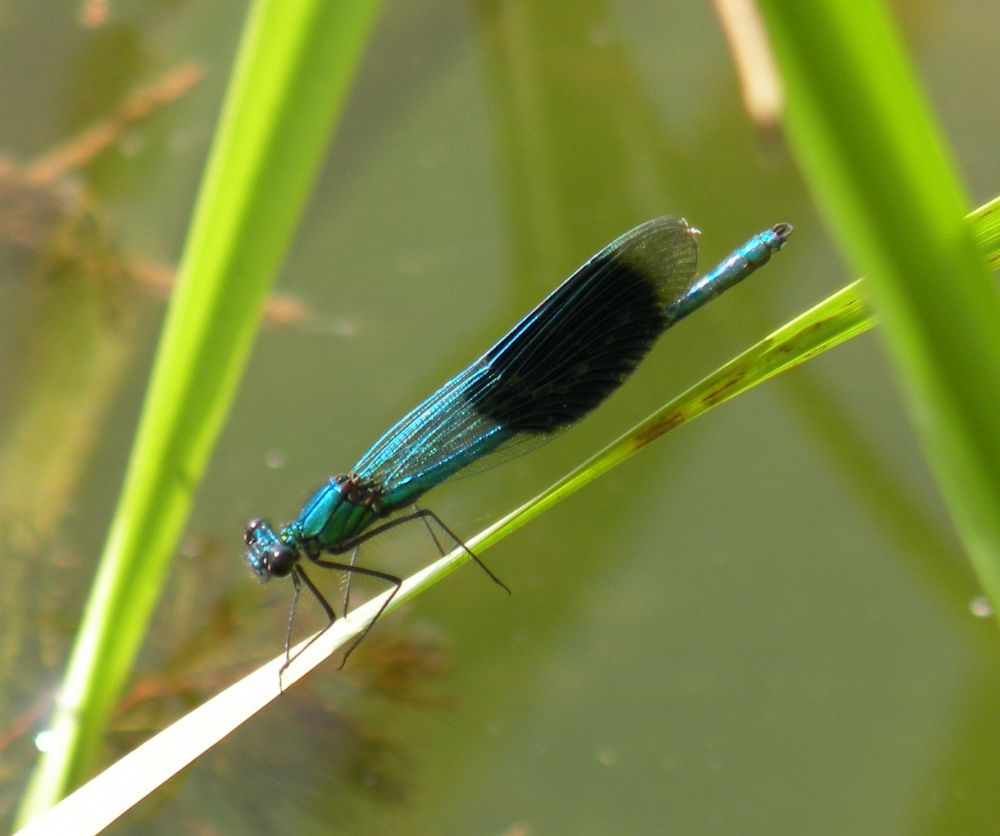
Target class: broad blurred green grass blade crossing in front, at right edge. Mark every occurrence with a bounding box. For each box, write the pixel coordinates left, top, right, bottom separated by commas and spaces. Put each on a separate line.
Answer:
761, 0, 1000, 614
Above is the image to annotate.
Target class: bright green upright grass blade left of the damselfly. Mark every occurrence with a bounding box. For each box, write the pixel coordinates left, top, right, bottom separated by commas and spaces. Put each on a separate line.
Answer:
19, 0, 386, 822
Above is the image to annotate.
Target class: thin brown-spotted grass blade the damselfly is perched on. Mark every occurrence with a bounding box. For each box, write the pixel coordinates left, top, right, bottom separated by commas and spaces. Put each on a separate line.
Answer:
19, 198, 1000, 836
